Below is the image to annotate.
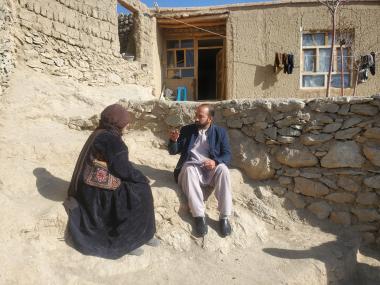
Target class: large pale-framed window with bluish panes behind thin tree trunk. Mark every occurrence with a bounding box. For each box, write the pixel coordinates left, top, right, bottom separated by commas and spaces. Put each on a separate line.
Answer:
301, 32, 352, 88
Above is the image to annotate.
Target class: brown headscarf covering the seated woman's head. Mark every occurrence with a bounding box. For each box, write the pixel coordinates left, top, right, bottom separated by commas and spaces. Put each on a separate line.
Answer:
98, 104, 130, 135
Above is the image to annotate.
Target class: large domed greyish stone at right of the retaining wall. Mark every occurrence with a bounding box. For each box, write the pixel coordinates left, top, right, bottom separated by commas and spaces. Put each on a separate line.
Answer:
321, 141, 365, 168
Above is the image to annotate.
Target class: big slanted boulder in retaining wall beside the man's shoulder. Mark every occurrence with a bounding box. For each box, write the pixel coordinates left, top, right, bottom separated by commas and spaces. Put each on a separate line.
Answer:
230, 130, 275, 180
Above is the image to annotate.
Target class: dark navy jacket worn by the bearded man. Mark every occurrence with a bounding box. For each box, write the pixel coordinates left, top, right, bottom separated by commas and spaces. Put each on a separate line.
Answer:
168, 124, 231, 182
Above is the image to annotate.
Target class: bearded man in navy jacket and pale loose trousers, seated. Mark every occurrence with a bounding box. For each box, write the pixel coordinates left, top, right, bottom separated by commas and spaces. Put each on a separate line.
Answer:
169, 104, 232, 237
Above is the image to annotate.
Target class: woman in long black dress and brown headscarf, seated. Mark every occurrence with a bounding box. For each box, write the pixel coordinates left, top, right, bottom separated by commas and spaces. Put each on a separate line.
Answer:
64, 104, 158, 258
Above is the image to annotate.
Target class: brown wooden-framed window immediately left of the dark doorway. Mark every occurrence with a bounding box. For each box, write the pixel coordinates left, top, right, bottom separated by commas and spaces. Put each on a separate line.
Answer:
166, 39, 194, 79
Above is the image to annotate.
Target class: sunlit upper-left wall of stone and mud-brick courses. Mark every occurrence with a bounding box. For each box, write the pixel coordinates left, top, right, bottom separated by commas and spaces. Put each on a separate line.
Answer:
12, 0, 154, 86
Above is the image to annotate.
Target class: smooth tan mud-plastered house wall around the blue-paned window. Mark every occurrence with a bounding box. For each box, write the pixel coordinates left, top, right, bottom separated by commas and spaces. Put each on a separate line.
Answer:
227, 1, 380, 99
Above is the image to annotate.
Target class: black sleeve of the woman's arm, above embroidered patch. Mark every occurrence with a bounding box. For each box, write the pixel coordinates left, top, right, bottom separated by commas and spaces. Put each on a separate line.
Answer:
94, 135, 149, 183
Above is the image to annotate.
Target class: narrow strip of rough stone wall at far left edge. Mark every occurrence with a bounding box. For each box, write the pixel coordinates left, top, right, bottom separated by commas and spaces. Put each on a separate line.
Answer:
0, 0, 15, 96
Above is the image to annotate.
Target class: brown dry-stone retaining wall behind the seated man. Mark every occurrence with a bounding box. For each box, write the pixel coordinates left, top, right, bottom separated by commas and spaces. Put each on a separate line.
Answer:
124, 95, 380, 243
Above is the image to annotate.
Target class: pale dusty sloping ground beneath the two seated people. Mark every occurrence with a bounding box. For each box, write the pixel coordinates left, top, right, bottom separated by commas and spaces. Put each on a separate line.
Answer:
0, 67, 380, 284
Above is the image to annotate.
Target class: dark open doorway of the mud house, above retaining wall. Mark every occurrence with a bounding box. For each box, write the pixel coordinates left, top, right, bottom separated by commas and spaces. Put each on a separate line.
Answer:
198, 48, 222, 100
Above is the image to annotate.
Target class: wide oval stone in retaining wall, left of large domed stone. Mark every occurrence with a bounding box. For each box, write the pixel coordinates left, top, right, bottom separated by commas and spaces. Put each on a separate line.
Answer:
275, 147, 318, 168
